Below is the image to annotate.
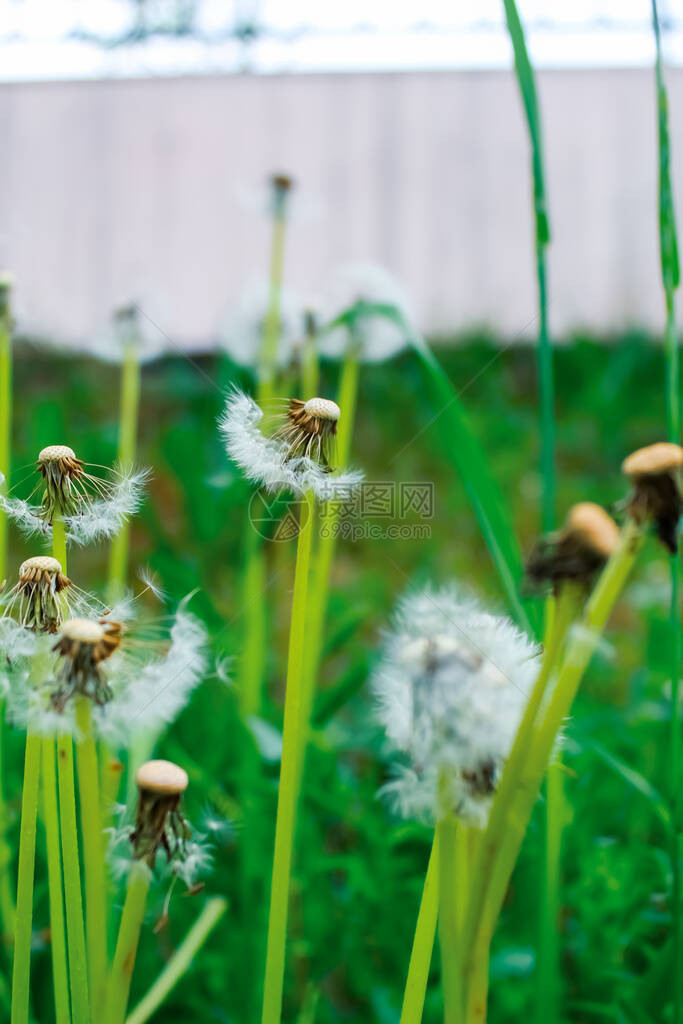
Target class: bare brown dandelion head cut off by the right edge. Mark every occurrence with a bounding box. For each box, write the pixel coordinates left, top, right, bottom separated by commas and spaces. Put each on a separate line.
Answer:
622, 441, 683, 554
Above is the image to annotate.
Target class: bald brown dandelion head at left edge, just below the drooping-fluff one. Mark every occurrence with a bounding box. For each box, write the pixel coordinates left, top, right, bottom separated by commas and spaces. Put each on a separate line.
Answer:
10, 555, 72, 633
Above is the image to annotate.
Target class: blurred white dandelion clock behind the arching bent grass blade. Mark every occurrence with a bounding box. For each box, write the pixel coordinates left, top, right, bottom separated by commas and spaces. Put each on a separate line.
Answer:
319, 263, 413, 362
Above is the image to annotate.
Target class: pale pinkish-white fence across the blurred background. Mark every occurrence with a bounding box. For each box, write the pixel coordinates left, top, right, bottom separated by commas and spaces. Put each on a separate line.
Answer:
0, 70, 683, 347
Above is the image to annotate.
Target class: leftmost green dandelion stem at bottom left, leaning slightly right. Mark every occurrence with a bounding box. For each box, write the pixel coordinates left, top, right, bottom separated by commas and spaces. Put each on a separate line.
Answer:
11, 734, 41, 1024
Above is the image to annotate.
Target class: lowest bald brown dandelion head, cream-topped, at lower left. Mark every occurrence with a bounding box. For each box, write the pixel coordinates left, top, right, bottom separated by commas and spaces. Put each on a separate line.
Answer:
131, 761, 189, 867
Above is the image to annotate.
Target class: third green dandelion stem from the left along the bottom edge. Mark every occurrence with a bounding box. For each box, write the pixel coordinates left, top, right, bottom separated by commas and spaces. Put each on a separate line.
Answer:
57, 736, 90, 1024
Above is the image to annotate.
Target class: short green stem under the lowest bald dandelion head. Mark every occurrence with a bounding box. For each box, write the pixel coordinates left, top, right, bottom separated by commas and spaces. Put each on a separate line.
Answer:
105, 861, 151, 1024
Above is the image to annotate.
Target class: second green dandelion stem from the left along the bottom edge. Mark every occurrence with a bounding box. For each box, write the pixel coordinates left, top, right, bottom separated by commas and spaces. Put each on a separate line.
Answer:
41, 737, 71, 1024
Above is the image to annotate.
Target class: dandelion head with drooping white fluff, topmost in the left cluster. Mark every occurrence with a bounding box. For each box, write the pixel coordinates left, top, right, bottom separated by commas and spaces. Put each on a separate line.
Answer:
0, 462, 150, 545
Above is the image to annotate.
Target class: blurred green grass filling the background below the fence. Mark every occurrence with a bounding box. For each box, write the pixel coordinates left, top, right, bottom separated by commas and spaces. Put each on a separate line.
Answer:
0, 335, 673, 1024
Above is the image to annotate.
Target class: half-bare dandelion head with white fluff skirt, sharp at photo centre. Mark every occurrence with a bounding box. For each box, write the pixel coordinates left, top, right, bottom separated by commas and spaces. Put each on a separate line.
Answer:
219, 389, 362, 501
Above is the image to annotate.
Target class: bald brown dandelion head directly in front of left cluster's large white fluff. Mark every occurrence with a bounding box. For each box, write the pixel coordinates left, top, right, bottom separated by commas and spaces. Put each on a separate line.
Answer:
52, 618, 123, 711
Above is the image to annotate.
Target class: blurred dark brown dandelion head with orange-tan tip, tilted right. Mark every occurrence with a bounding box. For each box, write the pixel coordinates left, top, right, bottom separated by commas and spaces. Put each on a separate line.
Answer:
525, 502, 618, 590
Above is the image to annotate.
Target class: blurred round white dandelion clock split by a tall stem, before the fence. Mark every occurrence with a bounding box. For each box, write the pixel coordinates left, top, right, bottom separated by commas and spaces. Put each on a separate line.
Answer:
220, 283, 305, 368
